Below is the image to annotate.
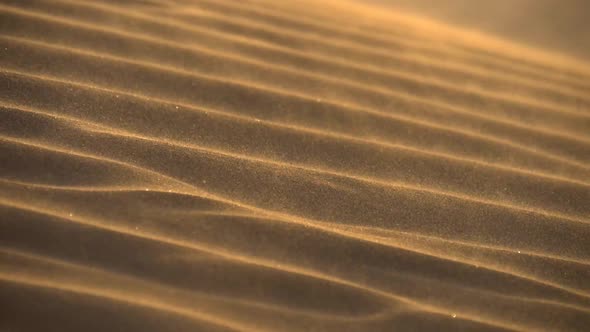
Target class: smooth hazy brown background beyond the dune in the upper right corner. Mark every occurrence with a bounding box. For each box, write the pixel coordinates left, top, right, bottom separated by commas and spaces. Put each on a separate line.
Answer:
359, 0, 590, 60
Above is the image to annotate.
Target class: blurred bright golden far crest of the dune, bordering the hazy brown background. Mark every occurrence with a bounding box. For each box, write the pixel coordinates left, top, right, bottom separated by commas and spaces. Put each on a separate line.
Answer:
240, 0, 590, 84
